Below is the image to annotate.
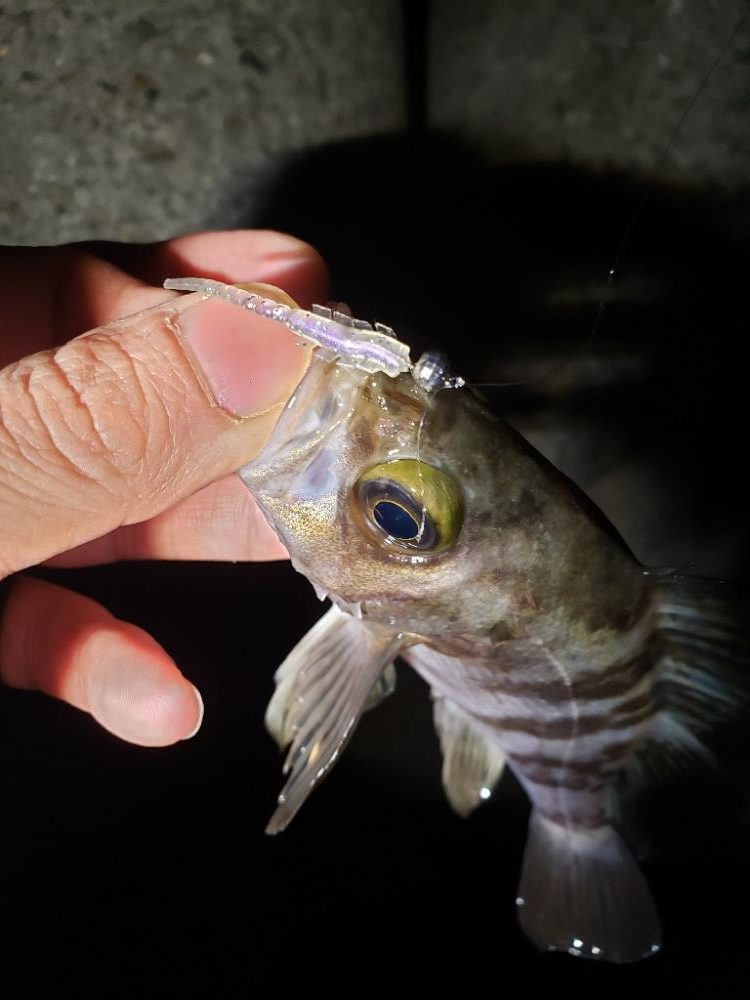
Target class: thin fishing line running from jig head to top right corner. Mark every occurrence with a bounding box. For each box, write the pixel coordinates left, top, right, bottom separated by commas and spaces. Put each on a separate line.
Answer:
467, 11, 748, 389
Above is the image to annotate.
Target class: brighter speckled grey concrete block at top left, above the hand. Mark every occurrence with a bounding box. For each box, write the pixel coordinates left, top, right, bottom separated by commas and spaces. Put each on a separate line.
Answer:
0, 0, 405, 244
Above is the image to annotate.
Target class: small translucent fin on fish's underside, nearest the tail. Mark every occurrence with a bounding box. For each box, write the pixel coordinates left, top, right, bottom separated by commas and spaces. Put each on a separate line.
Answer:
433, 693, 505, 816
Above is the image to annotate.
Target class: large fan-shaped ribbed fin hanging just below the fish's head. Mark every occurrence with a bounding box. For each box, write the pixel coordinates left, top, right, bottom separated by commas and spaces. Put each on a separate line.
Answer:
266, 605, 403, 833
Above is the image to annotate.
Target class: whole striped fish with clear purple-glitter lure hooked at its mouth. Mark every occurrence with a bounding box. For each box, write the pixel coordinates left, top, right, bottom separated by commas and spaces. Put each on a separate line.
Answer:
166, 279, 748, 962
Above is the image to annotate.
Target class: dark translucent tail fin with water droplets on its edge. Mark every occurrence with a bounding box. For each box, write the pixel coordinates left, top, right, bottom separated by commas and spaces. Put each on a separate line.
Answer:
516, 810, 661, 962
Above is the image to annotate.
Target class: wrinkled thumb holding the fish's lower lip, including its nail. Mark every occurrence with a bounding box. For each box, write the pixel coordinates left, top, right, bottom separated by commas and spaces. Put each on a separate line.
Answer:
0, 282, 309, 578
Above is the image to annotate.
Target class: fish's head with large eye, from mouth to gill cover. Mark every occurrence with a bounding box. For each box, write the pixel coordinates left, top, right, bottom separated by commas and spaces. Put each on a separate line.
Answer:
240, 340, 564, 638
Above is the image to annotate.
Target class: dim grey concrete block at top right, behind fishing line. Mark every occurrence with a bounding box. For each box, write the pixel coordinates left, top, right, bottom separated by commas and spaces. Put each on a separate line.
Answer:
429, 0, 750, 191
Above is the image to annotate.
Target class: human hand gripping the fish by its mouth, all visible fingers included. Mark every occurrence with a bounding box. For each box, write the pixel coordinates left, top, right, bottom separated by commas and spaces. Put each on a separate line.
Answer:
0, 231, 326, 746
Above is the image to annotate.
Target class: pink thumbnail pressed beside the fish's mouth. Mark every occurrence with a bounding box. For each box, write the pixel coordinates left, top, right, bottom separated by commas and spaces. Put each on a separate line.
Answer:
174, 299, 309, 417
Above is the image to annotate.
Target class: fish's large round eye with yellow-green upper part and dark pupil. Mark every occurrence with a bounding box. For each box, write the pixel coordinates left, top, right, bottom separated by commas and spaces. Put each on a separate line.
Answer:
354, 458, 463, 552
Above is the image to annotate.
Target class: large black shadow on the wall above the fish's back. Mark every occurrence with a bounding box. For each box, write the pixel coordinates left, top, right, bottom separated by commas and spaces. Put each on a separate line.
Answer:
234, 137, 750, 577
